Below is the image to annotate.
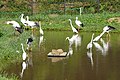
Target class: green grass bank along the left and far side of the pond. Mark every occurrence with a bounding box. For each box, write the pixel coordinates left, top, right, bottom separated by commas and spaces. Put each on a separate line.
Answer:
0, 13, 120, 80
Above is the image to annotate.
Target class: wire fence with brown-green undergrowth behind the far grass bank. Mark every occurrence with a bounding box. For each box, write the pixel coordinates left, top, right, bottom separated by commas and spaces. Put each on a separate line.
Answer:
0, 0, 120, 17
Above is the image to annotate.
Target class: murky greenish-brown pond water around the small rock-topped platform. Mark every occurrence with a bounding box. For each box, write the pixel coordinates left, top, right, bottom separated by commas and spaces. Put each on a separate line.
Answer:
2, 31, 120, 80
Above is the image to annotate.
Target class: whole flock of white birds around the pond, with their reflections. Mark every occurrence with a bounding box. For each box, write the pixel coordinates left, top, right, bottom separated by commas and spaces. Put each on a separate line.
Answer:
7, 14, 115, 76
